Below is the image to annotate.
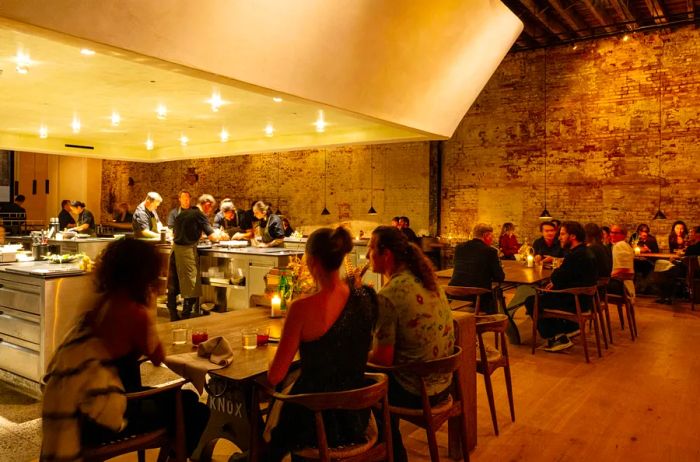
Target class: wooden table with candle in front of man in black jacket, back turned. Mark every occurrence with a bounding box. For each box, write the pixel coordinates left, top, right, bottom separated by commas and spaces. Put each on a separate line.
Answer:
436, 260, 552, 345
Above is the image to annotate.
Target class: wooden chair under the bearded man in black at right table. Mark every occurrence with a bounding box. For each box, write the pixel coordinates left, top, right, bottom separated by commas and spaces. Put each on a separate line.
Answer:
532, 286, 603, 363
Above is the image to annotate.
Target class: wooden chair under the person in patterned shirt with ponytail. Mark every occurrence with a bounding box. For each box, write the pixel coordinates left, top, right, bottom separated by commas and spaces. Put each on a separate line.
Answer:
368, 346, 469, 462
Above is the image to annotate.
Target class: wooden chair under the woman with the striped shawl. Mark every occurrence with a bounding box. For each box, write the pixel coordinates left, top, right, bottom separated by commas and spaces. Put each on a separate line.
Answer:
83, 379, 187, 462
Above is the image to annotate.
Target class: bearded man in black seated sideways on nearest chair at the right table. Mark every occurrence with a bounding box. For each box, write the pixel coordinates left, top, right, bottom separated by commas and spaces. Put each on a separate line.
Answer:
525, 221, 597, 352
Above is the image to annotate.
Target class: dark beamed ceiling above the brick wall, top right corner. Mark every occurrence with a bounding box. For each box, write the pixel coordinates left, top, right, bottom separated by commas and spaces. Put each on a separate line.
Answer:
503, 0, 700, 51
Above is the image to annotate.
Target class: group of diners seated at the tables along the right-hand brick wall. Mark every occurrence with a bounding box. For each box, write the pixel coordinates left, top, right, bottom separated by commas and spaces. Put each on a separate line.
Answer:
449, 221, 700, 351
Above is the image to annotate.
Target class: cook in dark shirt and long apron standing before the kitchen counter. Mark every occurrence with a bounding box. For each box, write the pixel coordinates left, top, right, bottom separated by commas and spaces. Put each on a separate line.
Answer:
167, 194, 228, 321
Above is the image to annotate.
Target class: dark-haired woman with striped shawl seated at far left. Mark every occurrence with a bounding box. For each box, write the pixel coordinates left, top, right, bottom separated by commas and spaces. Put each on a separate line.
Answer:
42, 239, 209, 460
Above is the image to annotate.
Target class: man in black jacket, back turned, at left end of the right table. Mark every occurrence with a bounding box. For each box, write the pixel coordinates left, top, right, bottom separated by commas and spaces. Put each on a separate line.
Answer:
449, 223, 506, 313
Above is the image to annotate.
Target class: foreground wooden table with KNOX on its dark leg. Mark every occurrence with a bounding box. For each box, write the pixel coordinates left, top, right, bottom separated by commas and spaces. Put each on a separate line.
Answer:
157, 308, 476, 461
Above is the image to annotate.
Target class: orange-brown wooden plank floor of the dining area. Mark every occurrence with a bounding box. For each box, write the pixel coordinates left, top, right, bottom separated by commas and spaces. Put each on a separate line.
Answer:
34, 298, 700, 462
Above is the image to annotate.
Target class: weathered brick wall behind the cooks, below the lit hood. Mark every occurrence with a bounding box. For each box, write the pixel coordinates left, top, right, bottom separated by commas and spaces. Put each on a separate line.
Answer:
102, 142, 429, 235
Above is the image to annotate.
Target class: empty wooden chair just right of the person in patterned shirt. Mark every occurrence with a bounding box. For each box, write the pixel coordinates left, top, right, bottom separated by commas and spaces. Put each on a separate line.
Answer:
476, 314, 515, 436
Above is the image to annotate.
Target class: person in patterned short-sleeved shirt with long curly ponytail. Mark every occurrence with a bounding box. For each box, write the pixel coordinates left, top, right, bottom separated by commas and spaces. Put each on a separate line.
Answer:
368, 226, 455, 461
